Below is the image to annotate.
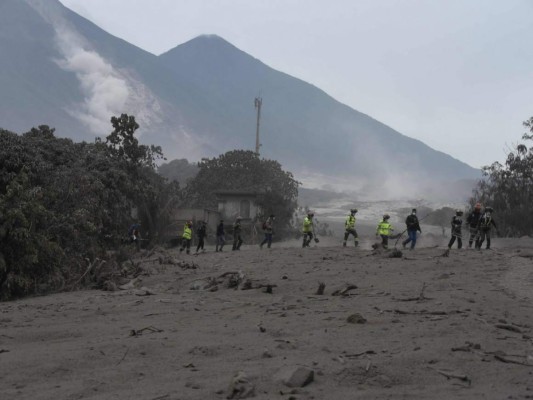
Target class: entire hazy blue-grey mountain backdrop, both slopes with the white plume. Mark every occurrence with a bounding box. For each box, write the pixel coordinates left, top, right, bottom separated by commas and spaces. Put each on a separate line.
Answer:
0, 0, 480, 195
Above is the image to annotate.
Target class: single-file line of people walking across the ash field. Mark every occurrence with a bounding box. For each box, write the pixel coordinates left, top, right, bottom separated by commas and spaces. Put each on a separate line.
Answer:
164, 203, 497, 254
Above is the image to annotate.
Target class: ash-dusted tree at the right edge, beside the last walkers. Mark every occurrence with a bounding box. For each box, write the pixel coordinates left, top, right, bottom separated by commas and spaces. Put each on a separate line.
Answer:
470, 117, 533, 237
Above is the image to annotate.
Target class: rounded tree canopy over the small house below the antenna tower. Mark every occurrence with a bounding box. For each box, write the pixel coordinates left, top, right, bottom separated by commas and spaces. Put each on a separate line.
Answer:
186, 150, 299, 236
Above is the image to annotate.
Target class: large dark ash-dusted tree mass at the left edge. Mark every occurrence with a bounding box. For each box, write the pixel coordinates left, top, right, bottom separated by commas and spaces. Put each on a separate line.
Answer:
0, 114, 179, 300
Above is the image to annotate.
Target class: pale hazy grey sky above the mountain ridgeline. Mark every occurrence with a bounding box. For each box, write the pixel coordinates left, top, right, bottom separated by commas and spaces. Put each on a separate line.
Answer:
61, 0, 533, 167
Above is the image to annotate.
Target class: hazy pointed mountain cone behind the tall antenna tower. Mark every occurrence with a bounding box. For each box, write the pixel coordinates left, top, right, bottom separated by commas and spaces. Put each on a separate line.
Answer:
160, 35, 478, 186
